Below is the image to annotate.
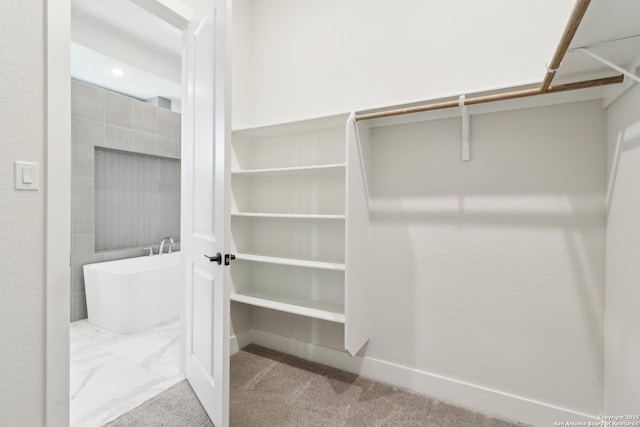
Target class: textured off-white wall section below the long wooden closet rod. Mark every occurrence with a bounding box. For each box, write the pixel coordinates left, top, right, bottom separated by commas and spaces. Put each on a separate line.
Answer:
367, 101, 606, 414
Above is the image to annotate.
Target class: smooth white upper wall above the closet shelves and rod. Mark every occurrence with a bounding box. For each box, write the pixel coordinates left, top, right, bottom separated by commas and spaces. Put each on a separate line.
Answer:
233, 0, 574, 129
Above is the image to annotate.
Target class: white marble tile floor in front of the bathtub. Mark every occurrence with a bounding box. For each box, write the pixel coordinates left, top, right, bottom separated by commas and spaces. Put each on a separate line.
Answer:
70, 319, 183, 427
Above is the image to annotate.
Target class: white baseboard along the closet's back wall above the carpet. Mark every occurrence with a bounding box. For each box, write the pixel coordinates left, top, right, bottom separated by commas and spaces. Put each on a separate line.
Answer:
239, 329, 597, 427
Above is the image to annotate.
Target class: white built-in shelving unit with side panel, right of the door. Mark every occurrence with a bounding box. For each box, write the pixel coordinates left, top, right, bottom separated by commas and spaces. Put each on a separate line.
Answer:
231, 116, 368, 354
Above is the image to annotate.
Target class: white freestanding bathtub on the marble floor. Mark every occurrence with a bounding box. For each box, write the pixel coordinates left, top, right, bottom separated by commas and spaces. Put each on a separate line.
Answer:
84, 252, 180, 334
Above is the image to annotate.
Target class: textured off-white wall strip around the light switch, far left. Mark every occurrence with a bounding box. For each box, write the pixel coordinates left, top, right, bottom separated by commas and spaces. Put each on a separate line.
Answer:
0, 1, 46, 426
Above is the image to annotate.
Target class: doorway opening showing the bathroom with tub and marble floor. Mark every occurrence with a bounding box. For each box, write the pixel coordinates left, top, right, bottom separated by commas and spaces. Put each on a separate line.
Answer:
69, 0, 184, 427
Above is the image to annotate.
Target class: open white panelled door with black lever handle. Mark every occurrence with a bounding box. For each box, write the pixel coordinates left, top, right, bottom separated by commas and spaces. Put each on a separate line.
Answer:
182, 0, 230, 427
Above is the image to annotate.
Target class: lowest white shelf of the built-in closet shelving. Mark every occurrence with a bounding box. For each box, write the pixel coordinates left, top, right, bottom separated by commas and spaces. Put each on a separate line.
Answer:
231, 290, 344, 323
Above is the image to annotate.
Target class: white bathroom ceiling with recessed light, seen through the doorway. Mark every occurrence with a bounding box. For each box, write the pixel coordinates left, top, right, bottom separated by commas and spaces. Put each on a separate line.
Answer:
71, 0, 182, 105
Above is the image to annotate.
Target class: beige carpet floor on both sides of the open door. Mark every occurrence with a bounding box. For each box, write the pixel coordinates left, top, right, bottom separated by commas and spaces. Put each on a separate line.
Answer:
107, 345, 524, 427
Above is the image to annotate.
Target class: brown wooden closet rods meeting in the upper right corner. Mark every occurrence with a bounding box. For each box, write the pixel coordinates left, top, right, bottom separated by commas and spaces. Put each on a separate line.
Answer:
355, 0, 624, 121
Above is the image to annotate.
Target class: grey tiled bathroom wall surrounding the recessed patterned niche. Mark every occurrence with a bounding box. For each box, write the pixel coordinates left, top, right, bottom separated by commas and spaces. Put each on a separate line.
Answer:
71, 80, 180, 321
